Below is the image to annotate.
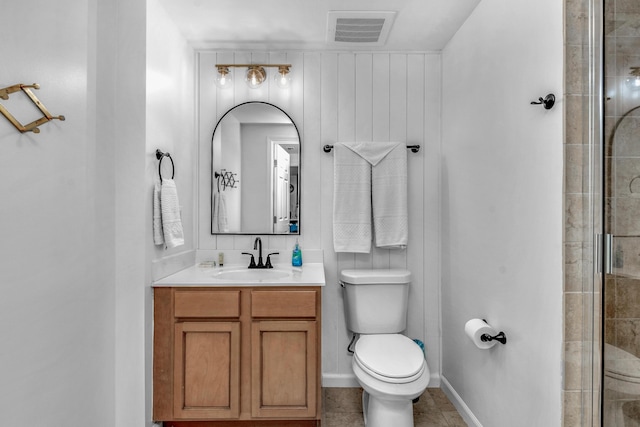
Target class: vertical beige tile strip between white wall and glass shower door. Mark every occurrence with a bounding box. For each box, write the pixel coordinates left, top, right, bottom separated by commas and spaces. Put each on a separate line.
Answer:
563, 0, 601, 427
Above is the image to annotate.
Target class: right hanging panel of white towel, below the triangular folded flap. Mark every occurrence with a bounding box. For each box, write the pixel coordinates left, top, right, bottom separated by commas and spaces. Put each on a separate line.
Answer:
371, 144, 409, 249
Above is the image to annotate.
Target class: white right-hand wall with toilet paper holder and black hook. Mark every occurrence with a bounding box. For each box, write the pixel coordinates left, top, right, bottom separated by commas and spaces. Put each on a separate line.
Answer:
442, 0, 563, 427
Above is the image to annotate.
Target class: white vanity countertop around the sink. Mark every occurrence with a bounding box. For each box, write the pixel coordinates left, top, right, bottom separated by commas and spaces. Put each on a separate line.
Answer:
153, 262, 325, 287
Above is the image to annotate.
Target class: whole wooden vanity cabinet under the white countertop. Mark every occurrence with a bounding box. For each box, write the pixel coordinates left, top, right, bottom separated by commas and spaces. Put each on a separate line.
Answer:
153, 287, 321, 427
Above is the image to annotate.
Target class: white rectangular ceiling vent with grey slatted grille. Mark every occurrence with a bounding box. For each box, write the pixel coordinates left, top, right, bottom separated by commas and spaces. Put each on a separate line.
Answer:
327, 10, 396, 46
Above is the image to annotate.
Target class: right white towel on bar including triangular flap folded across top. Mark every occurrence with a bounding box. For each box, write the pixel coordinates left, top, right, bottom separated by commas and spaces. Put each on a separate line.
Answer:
334, 141, 409, 249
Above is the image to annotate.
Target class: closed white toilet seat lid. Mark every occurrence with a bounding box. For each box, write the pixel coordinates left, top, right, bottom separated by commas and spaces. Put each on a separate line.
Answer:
354, 334, 426, 384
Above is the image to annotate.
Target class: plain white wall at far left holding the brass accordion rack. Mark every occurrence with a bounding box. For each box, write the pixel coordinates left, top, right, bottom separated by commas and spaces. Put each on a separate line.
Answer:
0, 0, 144, 427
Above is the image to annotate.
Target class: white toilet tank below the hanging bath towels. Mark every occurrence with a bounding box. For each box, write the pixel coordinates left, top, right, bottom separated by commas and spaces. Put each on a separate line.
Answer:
340, 269, 411, 334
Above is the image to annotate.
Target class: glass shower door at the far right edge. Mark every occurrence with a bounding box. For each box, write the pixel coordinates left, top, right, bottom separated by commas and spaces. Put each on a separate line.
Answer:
602, 0, 640, 427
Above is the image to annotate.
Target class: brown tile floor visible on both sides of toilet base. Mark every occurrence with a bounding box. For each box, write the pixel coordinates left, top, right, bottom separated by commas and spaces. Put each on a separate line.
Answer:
322, 388, 467, 427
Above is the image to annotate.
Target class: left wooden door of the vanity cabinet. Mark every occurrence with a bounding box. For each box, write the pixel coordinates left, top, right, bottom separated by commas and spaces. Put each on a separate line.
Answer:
174, 322, 240, 419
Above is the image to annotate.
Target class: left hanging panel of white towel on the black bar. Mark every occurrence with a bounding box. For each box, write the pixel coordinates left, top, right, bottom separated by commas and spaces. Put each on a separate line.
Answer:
333, 143, 371, 253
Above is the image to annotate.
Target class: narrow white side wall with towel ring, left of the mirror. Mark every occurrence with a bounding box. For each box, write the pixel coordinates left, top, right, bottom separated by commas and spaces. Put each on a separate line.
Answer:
146, 0, 197, 425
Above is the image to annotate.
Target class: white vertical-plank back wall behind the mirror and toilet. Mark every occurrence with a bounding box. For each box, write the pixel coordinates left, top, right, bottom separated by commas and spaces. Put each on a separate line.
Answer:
198, 52, 440, 386
